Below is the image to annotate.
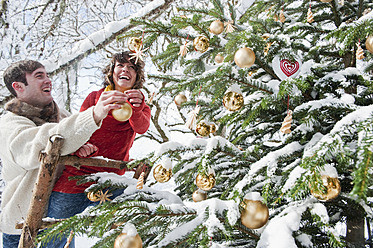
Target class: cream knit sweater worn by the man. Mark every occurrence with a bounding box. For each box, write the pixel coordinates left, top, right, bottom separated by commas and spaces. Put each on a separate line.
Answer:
0, 107, 99, 234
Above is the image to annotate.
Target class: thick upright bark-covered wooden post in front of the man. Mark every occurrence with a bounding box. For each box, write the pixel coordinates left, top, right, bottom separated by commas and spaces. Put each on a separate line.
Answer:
18, 135, 63, 248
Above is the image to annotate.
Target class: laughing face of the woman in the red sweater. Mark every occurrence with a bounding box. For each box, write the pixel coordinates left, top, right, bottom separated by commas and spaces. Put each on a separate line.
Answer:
113, 61, 136, 92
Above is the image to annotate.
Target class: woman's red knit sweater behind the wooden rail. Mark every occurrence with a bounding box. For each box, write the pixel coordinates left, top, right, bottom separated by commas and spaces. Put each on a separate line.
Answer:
53, 89, 150, 193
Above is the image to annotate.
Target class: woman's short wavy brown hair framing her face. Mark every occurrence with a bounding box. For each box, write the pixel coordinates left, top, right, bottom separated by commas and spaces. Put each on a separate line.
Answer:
102, 51, 145, 89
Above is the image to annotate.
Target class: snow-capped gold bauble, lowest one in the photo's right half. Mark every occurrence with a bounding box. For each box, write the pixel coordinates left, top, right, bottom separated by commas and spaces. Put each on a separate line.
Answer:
241, 199, 269, 229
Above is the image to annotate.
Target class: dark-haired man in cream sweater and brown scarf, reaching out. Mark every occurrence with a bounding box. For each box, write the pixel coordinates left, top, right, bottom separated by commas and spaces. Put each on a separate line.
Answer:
0, 60, 128, 248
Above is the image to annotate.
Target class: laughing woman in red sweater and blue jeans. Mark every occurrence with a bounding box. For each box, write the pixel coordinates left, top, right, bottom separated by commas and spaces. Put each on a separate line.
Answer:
48, 51, 150, 247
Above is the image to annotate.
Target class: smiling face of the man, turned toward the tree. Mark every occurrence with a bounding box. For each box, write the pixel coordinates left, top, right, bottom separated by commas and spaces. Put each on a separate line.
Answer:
19, 67, 53, 108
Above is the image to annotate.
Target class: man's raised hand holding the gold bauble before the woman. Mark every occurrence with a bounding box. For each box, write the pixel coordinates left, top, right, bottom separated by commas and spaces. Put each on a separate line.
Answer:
93, 90, 128, 124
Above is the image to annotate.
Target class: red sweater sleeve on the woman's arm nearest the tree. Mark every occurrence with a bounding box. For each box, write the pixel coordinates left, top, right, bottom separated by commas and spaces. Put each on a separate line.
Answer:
129, 95, 151, 134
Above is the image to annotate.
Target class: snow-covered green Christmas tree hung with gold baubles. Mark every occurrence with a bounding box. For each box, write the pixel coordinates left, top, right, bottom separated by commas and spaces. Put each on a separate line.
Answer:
35, 0, 373, 248
